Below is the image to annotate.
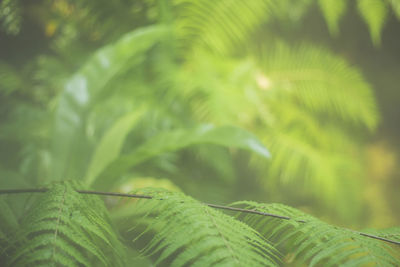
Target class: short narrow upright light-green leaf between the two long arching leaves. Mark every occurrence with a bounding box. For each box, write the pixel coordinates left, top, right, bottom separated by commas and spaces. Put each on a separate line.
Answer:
85, 110, 143, 185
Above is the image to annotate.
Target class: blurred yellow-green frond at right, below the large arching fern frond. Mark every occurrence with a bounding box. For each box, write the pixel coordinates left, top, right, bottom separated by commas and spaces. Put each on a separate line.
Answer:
264, 120, 363, 218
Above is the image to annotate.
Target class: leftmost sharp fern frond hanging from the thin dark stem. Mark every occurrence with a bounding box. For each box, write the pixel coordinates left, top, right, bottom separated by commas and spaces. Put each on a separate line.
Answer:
8, 182, 123, 266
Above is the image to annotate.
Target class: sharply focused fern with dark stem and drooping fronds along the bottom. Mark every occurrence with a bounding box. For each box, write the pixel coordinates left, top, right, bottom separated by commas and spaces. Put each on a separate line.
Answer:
0, 182, 400, 266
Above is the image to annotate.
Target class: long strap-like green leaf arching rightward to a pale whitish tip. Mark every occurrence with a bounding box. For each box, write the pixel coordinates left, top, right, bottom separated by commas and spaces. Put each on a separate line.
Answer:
92, 125, 270, 187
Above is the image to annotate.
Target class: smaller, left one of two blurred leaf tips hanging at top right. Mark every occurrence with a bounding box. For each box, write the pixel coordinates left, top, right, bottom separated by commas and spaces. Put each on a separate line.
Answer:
319, 0, 347, 36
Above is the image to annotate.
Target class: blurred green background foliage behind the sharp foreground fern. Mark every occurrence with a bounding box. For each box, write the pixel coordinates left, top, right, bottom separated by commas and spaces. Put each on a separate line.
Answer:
0, 0, 400, 266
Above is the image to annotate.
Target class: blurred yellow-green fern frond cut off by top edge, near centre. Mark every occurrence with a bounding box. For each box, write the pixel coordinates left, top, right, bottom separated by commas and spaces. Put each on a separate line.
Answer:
176, 0, 271, 54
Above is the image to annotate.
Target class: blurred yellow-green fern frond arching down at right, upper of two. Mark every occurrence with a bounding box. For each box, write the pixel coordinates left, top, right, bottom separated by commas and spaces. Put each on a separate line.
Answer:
260, 43, 378, 129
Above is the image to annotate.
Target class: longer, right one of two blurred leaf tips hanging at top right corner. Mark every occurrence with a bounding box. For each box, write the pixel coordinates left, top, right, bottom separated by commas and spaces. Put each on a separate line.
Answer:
358, 0, 388, 45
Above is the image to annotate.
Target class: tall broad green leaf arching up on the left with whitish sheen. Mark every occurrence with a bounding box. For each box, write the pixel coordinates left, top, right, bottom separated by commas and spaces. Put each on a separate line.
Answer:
52, 26, 166, 180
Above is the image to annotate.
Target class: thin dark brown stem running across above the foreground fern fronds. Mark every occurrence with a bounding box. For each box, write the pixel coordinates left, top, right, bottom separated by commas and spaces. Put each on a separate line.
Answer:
0, 188, 400, 245
